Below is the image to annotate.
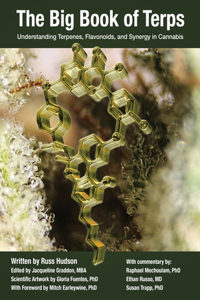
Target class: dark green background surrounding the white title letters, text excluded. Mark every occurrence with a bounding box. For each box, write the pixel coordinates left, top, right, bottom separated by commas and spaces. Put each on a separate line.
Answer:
0, 0, 200, 48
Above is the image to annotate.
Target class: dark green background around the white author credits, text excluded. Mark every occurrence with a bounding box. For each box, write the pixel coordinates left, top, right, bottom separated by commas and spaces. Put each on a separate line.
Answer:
0, 252, 200, 300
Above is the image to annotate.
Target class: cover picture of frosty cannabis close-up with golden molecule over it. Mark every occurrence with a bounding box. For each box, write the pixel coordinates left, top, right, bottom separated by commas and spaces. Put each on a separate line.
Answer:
0, 44, 200, 265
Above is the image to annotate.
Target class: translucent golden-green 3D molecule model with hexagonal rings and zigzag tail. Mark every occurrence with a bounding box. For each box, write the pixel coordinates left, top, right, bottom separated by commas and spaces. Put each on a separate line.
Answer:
37, 44, 151, 265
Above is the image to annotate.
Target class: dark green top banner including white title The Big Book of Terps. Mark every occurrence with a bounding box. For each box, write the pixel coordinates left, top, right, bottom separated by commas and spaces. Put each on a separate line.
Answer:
0, 0, 200, 48
